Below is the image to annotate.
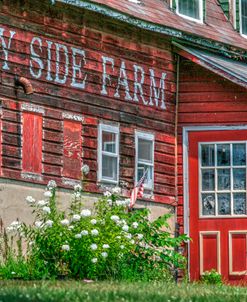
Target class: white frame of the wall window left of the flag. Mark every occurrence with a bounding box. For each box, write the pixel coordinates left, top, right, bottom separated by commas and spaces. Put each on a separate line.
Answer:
98, 123, 119, 184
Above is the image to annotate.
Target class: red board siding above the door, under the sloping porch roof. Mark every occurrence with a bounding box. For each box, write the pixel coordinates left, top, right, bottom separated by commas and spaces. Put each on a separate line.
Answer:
177, 59, 247, 232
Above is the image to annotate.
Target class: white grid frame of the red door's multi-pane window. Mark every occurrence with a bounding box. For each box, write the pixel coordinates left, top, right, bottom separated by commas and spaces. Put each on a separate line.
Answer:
198, 140, 247, 219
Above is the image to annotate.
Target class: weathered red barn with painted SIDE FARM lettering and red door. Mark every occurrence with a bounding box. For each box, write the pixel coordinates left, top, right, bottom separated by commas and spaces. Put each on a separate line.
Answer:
0, 0, 247, 282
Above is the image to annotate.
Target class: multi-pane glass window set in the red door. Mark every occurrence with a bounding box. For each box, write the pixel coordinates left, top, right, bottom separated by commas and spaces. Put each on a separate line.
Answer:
200, 142, 247, 216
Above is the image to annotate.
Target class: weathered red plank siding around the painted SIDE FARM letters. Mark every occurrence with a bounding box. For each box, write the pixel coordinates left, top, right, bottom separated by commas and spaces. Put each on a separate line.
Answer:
0, 4, 176, 203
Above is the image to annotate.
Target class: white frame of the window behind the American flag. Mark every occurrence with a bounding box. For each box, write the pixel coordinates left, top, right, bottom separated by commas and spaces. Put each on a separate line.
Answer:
135, 131, 155, 191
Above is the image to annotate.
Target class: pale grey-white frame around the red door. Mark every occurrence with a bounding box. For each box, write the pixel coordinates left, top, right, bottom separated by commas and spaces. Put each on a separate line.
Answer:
182, 125, 247, 279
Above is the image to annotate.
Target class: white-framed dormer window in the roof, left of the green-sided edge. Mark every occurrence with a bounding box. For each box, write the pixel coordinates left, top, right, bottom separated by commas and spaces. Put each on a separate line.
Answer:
176, 0, 203, 22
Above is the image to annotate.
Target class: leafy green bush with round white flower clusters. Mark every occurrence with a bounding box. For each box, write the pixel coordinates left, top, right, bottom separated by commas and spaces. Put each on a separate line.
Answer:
0, 181, 187, 280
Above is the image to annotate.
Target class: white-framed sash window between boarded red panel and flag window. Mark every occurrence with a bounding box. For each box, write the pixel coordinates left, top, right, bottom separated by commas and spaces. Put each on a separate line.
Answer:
98, 124, 119, 183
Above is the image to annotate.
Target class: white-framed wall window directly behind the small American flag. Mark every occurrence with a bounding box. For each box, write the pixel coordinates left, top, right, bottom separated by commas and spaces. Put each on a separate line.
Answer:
135, 131, 154, 190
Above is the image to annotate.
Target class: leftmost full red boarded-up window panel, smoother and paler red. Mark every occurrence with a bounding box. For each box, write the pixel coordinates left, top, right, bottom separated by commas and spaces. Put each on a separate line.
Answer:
22, 112, 42, 174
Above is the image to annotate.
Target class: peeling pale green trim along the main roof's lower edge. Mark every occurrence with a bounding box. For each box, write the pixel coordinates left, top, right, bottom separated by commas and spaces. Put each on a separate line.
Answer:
56, 0, 247, 59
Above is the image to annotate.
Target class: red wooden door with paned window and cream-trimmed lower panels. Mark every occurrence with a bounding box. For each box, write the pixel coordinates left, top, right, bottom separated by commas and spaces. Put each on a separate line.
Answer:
189, 130, 247, 283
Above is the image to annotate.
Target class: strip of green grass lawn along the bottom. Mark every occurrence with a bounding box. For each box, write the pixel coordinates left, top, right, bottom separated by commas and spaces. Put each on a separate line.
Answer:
0, 281, 247, 302
